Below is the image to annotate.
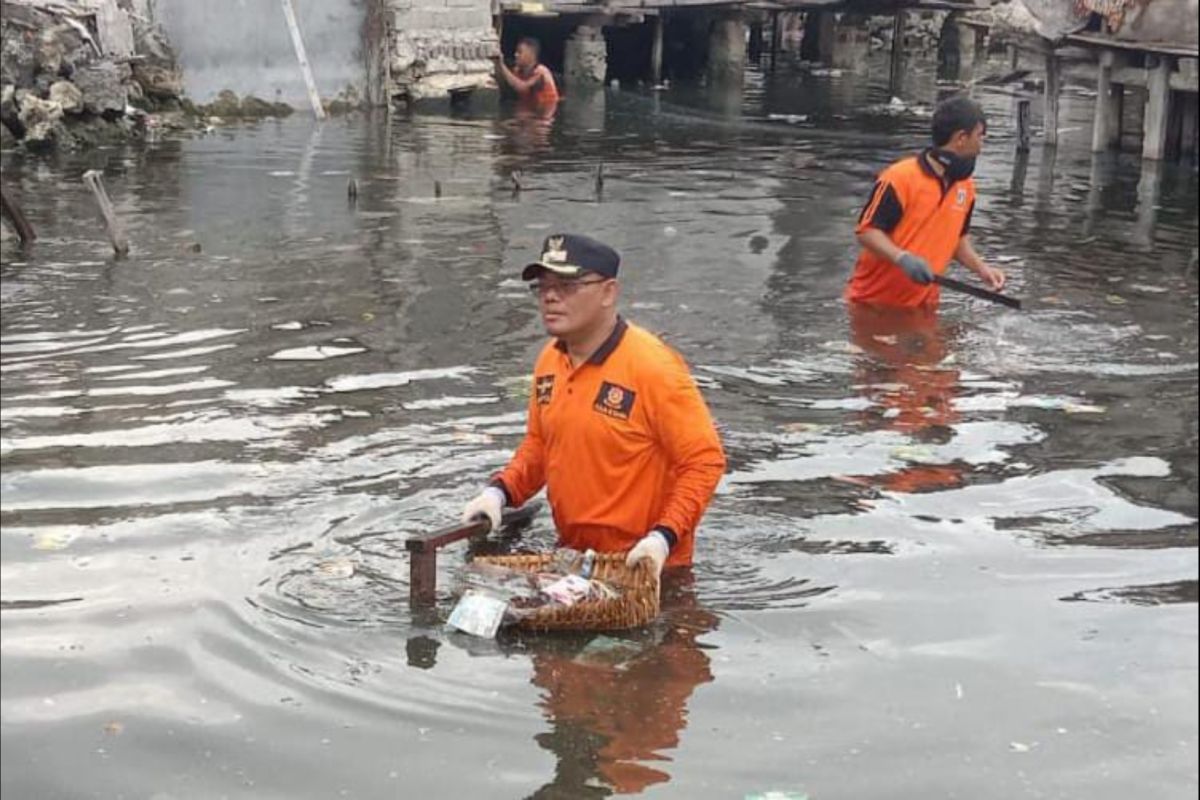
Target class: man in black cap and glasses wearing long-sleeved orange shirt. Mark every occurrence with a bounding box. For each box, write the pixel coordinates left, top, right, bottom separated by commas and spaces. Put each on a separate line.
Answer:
463, 234, 725, 573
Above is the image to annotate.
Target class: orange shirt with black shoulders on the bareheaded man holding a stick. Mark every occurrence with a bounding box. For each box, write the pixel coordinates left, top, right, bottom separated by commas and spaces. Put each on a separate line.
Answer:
846, 154, 976, 307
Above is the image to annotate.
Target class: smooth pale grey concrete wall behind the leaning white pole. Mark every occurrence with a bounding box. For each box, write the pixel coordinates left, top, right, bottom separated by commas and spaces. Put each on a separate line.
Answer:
155, 0, 366, 108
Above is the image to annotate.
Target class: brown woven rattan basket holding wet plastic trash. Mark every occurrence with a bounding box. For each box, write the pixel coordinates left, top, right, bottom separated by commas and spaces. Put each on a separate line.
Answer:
475, 553, 659, 631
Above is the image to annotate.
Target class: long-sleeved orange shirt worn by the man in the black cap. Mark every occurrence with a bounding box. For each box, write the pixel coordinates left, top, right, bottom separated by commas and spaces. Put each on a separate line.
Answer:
494, 320, 725, 566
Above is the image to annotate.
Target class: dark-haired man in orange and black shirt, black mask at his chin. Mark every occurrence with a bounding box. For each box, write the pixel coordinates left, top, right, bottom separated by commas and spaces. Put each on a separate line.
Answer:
846, 96, 1006, 308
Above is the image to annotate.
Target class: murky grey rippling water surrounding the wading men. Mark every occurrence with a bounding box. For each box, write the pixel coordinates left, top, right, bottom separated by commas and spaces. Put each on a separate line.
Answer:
0, 53, 1200, 798
